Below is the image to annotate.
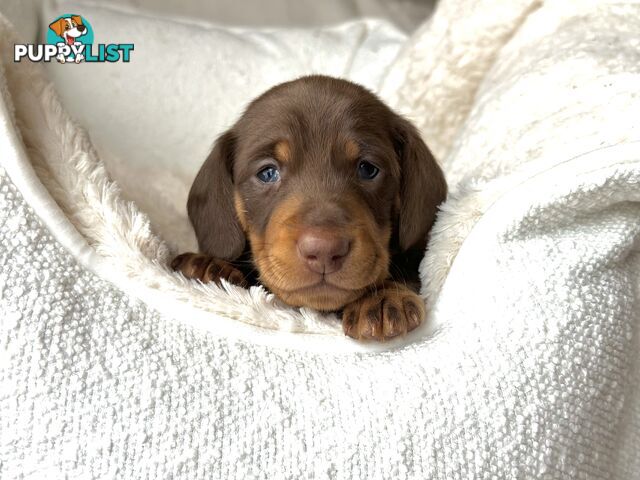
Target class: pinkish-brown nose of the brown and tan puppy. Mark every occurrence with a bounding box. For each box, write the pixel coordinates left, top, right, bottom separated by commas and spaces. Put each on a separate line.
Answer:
298, 229, 351, 273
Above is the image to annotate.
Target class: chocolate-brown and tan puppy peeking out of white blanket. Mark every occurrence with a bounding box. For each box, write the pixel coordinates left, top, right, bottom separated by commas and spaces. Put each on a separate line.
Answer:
172, 76, 447, 340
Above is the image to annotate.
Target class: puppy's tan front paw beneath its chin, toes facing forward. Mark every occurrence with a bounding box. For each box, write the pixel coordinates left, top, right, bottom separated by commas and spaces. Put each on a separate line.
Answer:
342, 282, 426, 340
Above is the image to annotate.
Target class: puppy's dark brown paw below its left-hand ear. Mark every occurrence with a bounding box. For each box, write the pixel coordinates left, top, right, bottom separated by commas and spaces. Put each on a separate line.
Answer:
171, 253, 247, 287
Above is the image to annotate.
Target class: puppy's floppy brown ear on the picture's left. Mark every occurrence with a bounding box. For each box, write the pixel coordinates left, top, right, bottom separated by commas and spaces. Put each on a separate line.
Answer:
187, 131, 246, 260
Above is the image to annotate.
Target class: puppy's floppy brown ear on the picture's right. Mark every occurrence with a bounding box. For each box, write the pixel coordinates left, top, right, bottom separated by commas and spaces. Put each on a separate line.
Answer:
393, 117, 447, 251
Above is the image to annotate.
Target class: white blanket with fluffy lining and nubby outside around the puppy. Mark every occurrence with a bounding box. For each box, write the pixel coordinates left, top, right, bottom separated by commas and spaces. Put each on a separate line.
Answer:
0, 0, 640, 479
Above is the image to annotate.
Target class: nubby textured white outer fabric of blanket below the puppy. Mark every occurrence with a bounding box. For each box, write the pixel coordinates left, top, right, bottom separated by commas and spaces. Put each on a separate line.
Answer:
0, 160, 640, 479
